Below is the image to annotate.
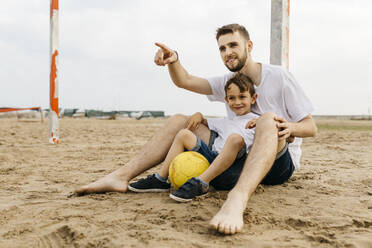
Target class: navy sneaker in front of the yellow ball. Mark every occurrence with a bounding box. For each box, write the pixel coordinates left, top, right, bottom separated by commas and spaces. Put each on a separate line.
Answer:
169, 177, 209, 202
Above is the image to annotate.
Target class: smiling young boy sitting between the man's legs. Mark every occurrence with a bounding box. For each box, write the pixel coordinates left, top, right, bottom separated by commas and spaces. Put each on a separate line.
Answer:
128, 74, 290, 202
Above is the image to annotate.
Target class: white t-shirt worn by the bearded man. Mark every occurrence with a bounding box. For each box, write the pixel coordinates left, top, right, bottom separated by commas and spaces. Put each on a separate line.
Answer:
207, 64, 314, 169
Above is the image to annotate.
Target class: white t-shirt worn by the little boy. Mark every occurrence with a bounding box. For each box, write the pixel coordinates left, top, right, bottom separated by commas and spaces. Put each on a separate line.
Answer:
207, 113, 259, 153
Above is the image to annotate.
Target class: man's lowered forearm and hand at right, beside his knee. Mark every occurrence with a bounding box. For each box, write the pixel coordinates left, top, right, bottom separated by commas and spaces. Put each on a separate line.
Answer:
275, 115, 318, 140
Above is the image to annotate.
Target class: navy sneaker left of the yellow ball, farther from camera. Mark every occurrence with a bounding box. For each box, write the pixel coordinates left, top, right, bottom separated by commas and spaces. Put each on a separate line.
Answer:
128, 174, 170, 193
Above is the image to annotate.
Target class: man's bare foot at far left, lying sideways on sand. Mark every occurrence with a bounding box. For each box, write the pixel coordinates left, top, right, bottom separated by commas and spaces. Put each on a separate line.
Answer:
75, 174, 128, 196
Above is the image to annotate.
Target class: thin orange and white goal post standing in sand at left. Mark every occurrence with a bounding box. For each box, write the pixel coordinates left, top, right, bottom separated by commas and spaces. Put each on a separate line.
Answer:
49, 0, 59, 144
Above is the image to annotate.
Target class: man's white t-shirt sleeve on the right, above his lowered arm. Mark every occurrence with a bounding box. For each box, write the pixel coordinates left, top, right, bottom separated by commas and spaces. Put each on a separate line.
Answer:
283, 72, 314, 122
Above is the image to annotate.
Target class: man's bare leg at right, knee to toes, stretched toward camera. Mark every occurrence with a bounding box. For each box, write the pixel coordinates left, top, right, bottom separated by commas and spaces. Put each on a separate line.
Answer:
210, 113, 278, 234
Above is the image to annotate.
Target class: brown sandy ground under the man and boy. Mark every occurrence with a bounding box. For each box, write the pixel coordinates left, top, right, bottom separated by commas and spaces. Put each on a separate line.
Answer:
0, 118, 372, 248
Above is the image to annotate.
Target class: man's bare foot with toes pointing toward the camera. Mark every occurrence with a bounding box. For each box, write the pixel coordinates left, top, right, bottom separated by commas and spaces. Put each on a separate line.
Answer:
209, 192, 246, 234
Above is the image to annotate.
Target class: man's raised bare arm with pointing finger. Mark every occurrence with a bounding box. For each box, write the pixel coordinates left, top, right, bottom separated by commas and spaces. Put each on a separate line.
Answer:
154, 43, 212, 95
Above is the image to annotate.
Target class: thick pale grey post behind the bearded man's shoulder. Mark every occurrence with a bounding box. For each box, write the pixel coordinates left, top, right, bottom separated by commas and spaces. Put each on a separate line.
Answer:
270, 0, 290, 70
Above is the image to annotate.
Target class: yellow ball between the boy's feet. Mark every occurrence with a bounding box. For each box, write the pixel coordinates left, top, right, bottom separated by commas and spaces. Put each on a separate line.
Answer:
169, 151, 209, 189
